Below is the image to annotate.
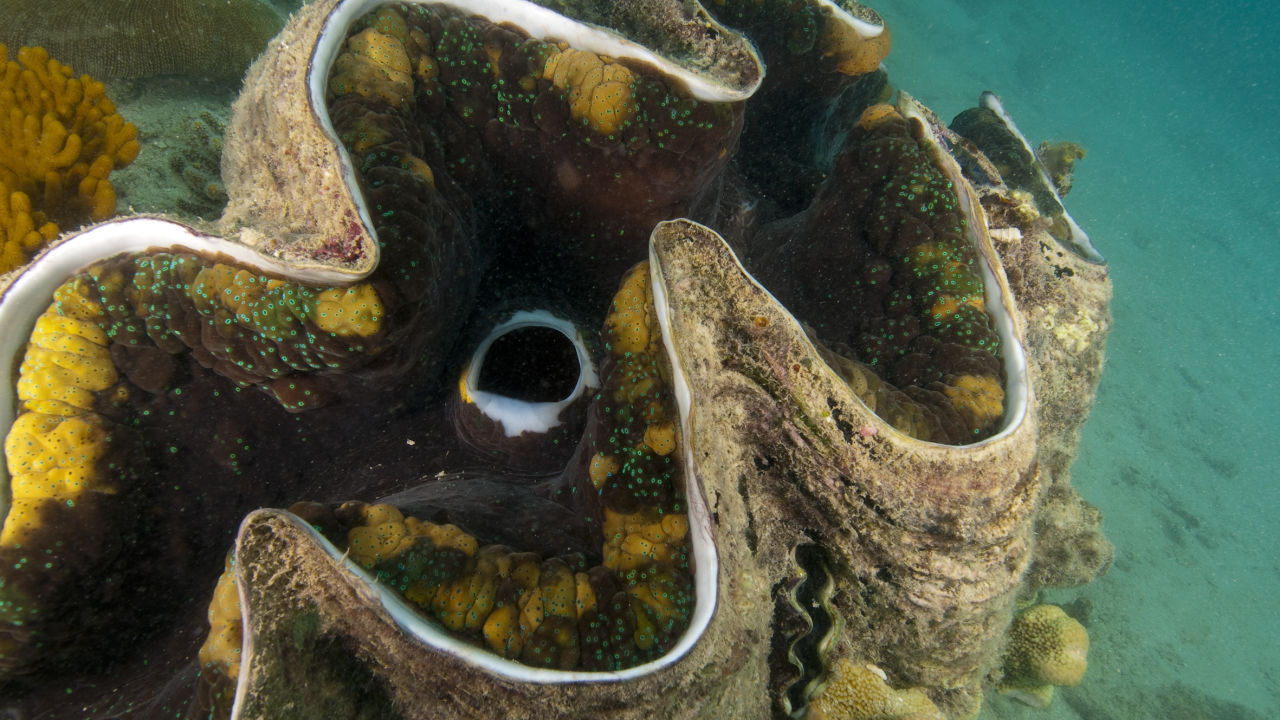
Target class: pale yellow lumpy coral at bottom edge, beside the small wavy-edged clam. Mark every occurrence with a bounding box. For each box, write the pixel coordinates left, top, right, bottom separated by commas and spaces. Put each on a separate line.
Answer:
805, 657, 945, 720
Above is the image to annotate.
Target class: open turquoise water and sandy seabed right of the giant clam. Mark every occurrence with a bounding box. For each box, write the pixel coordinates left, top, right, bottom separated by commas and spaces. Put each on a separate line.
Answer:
876, 0, 1280, 720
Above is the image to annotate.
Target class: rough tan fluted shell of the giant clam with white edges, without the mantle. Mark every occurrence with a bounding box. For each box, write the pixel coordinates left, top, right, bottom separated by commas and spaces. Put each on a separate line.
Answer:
0, 0, 1110, 720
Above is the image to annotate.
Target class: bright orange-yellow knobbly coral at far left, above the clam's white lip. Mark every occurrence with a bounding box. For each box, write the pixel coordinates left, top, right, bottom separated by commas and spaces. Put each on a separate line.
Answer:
0, 44, 140, 272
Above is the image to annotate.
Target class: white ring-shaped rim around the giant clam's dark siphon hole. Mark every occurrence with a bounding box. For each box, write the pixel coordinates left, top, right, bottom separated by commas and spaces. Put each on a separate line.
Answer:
462, 310, 600, 437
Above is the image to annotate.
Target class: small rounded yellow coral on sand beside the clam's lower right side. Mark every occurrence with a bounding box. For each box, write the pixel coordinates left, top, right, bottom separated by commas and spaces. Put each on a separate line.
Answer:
1000, 597, 1089, 707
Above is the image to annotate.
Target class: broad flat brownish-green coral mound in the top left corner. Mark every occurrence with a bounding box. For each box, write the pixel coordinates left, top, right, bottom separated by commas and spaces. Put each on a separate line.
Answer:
0, 0, 283, 82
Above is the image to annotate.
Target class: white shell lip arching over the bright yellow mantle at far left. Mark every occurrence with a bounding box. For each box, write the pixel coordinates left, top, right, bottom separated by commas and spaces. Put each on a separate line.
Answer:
0, 217, 366, 507
